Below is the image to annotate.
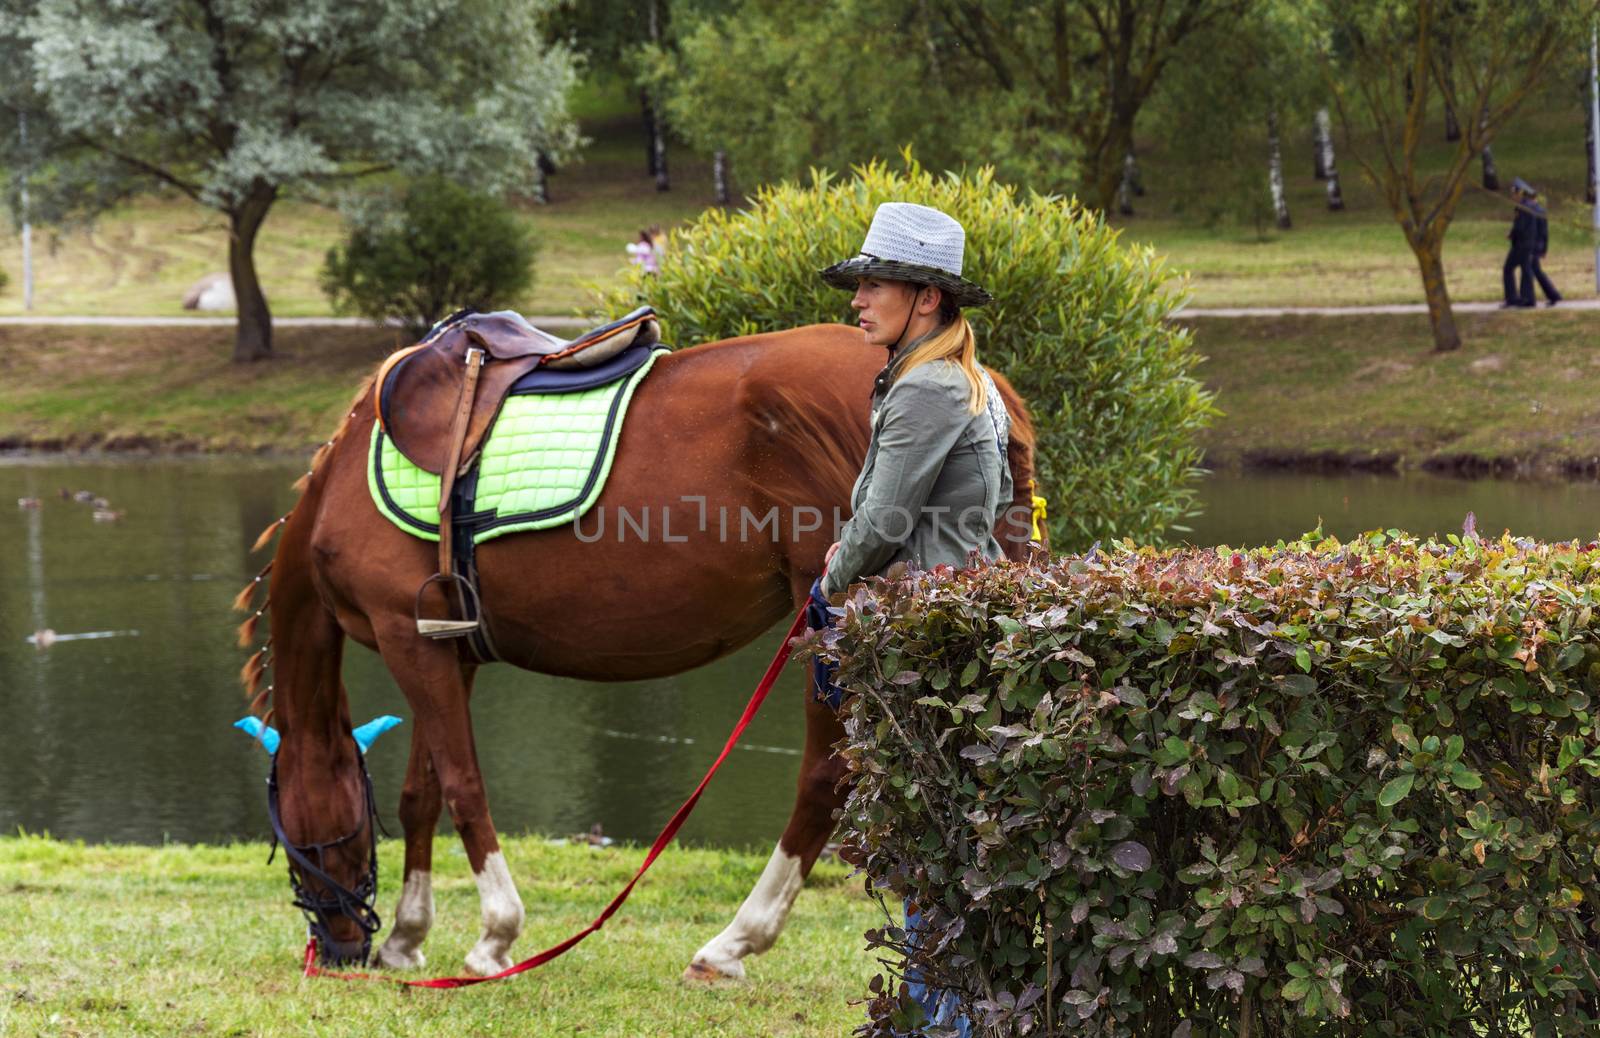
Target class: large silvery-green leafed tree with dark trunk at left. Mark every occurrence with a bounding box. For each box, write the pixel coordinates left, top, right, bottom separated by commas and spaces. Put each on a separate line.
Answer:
0, 0, 576, 361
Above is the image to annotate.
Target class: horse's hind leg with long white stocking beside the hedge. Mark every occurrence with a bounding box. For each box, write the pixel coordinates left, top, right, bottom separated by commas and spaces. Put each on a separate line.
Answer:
683, 592, 845, 980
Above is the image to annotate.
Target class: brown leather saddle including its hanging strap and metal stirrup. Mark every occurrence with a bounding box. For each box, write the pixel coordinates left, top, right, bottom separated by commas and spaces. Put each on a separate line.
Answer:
373, 307, 661, 638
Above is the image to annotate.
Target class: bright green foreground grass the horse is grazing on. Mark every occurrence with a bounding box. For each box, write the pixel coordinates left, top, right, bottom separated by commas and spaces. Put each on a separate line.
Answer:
0, 836, 882, 1038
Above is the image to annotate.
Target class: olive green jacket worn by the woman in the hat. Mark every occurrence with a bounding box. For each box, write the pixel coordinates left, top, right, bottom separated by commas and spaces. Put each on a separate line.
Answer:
822, 349, 1011, 595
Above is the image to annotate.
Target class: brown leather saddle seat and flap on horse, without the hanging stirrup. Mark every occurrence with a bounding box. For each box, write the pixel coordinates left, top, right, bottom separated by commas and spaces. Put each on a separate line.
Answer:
373, 307, 661, 475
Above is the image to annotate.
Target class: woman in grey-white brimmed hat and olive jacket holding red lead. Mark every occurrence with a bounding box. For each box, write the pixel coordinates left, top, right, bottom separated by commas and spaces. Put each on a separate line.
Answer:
811, 202, 1011, 1036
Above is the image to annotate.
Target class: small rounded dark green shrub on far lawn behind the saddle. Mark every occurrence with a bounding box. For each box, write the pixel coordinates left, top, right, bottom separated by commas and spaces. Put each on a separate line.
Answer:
322, 176, 538, 333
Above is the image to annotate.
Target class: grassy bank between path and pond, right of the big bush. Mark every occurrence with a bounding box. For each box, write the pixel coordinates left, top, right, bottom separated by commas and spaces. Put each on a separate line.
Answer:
1190, 310, 1600, 464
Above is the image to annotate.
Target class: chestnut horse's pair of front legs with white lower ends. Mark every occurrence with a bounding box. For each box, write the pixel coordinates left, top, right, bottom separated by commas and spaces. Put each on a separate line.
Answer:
368, 623, 523, 976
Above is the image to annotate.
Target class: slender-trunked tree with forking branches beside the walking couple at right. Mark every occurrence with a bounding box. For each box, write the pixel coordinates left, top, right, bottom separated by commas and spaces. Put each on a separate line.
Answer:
1322, 0, 1595, 350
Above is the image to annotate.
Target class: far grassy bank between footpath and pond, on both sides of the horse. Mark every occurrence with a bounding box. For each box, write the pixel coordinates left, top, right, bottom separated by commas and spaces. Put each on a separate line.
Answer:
0, 310, 1600, 467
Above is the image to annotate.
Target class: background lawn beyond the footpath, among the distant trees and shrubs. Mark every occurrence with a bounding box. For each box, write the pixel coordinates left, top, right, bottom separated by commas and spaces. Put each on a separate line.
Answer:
0, 85, 1594, 317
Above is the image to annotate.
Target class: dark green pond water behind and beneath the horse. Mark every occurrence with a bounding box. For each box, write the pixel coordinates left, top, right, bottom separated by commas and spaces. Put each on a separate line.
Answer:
0, 457, 1600, 849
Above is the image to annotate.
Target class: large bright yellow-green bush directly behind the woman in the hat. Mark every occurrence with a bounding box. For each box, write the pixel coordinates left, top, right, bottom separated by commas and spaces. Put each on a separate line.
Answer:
605, 158, 1214, 549
